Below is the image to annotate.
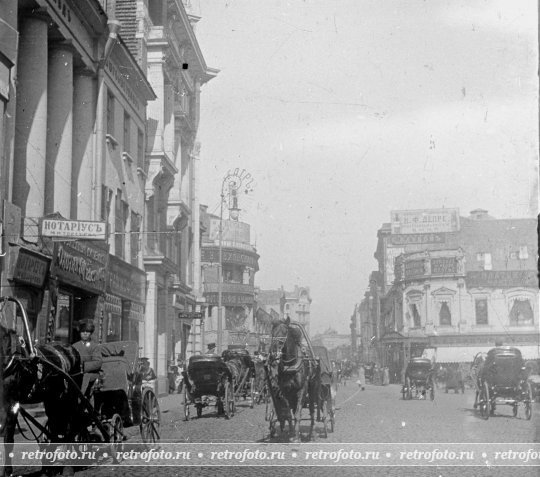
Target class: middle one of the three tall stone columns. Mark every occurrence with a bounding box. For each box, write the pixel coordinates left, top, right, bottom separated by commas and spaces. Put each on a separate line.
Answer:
45, 43, 73, 218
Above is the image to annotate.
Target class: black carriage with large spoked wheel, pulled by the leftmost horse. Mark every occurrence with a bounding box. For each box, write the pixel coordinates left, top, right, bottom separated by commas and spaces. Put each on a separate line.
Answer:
93, 341, 161, 444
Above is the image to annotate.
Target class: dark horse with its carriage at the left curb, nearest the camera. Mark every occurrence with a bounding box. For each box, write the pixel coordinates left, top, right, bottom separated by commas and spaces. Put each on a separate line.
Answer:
0, 297, 160, 472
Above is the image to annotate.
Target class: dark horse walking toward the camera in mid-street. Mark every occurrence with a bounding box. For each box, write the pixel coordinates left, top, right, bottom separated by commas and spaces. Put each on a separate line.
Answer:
267, 318, 318, 442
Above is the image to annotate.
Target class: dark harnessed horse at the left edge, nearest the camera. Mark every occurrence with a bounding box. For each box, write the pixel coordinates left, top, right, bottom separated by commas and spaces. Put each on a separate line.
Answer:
0, 300, 87, 475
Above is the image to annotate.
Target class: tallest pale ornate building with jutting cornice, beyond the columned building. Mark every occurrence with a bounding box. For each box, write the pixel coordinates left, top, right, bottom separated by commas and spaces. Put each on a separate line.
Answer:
116, 0, 217, 392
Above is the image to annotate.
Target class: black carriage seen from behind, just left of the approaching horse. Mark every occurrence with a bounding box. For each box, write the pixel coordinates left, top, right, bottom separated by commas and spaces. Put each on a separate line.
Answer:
184, 354, 235, 421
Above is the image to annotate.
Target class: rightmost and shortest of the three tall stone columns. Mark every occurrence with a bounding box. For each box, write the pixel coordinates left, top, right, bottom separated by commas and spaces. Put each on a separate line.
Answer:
71, 69, 97, 220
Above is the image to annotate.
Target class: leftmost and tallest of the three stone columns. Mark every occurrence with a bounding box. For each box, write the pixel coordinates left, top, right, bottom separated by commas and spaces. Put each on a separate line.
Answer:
13, 17, 48, 217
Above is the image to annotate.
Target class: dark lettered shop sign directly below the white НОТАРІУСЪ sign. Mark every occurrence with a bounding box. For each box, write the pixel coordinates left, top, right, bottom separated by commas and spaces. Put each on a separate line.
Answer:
51, 241, 109, 293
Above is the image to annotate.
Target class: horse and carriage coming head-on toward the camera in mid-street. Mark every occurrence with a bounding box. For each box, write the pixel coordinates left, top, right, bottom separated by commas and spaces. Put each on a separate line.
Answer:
264, 318, 334, 441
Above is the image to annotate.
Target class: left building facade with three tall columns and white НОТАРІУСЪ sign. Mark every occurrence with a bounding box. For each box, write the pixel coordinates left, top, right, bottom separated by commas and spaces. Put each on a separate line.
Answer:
1, 0, 155, 352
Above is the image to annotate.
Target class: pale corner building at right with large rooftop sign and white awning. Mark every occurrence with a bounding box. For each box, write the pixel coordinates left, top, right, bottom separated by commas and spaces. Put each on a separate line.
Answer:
366, 209, 540, 380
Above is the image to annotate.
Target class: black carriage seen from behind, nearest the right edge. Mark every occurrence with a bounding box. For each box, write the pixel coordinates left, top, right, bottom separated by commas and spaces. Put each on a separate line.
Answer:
478, 346, 533, 420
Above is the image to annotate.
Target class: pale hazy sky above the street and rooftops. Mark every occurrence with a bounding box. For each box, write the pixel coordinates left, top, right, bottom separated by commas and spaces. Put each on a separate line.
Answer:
190, 0, 538, 334
